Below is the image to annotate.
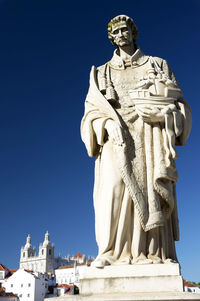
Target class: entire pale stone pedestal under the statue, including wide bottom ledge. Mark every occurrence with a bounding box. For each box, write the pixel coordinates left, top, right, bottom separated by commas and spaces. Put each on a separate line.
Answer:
45, 263, 200, 301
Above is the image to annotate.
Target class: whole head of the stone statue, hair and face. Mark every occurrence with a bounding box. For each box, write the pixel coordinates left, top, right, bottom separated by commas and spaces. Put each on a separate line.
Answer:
108, 15, 138, 46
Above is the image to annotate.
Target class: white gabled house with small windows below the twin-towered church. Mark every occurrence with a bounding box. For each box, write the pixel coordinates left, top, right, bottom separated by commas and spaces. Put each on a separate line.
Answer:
3, 269, 48, 301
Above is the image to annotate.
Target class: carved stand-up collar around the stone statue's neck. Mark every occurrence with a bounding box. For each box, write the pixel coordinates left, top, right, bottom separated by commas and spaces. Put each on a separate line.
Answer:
108, 48, 149, 70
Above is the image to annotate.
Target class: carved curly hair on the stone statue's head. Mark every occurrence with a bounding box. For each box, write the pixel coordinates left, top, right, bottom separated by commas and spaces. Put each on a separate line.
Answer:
108, 15, 138, 45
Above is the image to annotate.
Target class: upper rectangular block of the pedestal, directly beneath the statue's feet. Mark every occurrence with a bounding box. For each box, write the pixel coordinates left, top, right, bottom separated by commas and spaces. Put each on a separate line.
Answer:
80, 263, 183, 295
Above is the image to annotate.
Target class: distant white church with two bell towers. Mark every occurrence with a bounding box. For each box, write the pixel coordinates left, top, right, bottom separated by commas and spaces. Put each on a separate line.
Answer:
20, 231, 54, 274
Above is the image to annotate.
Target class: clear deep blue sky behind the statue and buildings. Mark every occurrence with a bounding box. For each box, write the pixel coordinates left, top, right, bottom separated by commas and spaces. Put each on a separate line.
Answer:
0, 0, 200, 281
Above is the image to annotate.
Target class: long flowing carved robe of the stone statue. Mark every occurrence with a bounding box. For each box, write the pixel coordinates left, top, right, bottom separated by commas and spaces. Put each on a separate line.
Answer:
81, 50, 191, 264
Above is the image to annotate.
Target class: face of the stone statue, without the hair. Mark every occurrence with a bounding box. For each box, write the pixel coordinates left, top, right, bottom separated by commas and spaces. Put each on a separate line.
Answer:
111, 22, 133, 47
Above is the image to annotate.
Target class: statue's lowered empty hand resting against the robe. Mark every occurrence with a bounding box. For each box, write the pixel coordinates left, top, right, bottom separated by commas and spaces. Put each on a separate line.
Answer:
105, 119, 124, 145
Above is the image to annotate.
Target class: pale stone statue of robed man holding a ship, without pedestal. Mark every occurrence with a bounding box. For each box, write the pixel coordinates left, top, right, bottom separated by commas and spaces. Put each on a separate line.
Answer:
81, 15, 191, 268
